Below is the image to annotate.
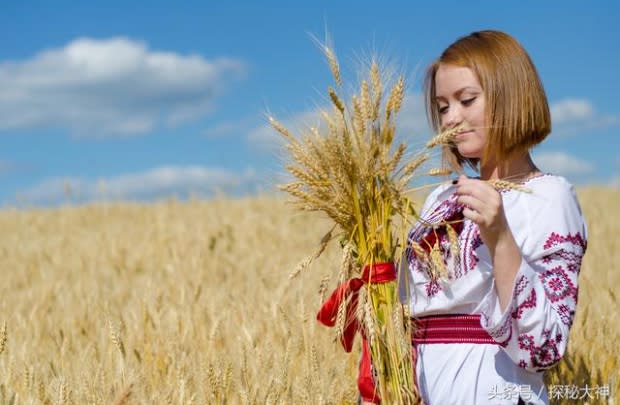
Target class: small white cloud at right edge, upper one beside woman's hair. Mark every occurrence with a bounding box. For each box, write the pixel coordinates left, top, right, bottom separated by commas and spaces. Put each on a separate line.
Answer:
550, 98, 620, 135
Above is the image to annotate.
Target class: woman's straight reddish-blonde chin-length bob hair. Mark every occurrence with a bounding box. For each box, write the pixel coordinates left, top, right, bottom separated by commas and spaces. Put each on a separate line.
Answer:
424, 31, 551, 171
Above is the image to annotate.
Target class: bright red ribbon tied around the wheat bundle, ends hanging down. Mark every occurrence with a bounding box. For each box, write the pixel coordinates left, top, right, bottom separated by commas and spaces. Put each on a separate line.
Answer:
316, 263, 396, 404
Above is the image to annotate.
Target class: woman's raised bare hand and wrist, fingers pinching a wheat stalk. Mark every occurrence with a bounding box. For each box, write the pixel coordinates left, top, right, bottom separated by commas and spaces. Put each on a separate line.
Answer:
456, 175, 512, 249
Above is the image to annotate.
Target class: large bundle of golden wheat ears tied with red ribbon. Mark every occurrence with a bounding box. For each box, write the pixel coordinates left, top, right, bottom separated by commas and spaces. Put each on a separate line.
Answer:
269, 46, 452, 404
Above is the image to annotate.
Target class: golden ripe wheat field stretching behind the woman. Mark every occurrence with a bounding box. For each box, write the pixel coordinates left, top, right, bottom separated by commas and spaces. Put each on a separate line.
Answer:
0, 188, 620, 405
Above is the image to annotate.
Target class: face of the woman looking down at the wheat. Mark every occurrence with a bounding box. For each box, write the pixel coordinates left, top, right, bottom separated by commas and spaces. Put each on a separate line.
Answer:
435, 64, 487, 158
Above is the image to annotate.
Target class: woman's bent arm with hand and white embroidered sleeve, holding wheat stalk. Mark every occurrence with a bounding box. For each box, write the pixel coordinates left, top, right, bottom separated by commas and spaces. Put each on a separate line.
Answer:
457, 175, 587, 371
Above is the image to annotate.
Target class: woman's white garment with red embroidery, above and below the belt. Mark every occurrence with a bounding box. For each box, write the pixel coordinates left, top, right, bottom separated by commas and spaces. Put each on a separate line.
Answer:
399, 174, 587, 405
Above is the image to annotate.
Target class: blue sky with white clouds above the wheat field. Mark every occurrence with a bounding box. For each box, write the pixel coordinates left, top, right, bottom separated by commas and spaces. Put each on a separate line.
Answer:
0, 0, 620, 206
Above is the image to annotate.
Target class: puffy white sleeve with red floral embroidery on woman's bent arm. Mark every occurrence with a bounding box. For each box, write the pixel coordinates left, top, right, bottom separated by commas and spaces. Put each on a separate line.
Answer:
481, 181, 587, 371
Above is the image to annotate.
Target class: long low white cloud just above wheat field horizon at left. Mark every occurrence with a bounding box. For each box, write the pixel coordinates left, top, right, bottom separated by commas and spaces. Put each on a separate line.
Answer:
17, 166, 256, 203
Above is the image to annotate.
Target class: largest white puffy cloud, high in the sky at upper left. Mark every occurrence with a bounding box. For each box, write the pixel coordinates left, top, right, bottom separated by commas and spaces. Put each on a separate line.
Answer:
0, 38, 244, 136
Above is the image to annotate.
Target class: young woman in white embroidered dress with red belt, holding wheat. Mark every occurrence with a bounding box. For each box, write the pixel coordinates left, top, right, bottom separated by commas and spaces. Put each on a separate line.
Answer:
360, 31, 587, 405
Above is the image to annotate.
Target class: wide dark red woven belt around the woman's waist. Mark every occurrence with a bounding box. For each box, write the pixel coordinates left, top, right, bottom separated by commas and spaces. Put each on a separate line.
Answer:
412, 314, 499, 345
